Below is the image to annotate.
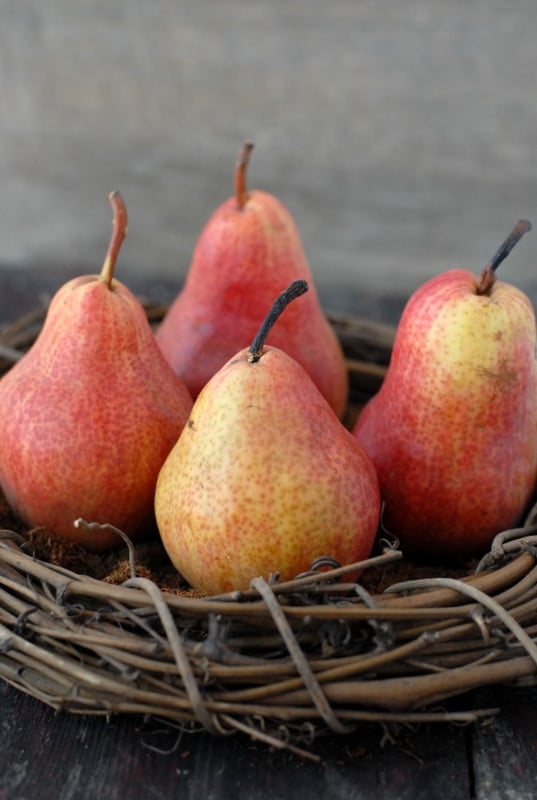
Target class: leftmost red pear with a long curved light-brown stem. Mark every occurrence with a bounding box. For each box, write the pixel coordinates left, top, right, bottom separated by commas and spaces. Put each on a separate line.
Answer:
0, 192, 192, 551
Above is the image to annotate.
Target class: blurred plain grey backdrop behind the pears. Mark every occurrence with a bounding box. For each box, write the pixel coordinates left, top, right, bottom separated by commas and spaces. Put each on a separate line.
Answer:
0, 0, 537, 316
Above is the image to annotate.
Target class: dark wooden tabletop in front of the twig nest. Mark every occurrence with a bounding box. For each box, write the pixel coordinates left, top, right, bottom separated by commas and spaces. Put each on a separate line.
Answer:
0, 683, 537, 800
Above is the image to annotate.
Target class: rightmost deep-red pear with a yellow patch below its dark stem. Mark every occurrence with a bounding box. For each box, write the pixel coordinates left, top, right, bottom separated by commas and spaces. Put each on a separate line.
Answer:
353, 216, 537, 558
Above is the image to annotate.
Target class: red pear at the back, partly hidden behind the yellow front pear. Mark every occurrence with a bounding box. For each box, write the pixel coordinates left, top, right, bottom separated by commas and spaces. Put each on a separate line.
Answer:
156, 143, 348, 416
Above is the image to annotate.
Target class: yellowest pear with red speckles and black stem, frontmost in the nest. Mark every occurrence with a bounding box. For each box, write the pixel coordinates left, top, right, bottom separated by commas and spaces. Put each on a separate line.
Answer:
155, 280, 380, 594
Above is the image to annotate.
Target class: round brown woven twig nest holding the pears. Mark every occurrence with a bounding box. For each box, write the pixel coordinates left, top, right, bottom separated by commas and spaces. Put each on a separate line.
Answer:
0, 303, 537, 754
